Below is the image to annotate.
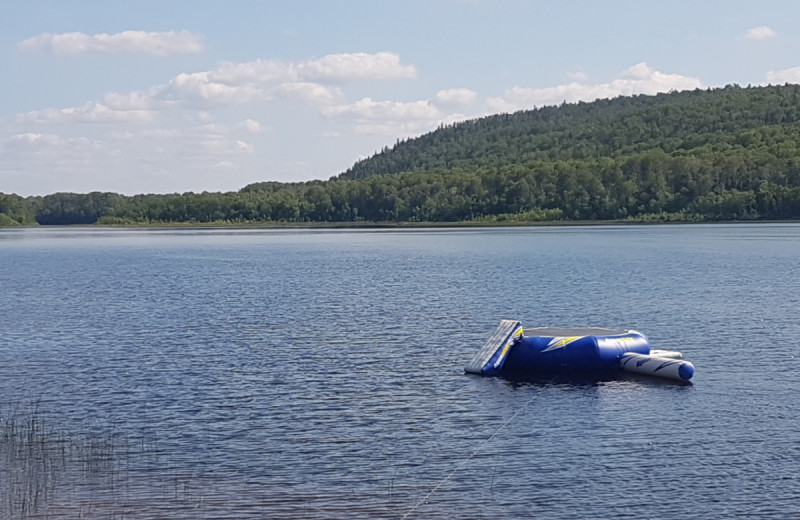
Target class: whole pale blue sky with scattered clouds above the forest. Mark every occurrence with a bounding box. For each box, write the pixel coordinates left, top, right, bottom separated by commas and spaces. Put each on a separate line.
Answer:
0, 0, 800, 196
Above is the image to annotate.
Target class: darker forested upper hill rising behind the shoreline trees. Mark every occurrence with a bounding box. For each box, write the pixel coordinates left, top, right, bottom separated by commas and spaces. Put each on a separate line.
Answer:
340, 85, 800, 179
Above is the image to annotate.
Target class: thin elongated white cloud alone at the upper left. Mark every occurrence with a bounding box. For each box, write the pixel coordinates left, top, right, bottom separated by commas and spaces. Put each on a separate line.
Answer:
17, 31, 204, 56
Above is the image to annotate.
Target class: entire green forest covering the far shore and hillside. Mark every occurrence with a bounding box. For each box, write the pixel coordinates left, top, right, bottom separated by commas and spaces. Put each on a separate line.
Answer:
0, 84, 800, 226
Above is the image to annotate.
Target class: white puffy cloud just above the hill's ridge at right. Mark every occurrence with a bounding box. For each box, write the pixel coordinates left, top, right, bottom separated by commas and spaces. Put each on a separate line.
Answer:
487, 62, 703, 112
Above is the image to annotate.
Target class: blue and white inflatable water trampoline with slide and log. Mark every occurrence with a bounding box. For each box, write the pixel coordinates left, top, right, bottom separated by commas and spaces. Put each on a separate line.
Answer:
464, 320, 694, 382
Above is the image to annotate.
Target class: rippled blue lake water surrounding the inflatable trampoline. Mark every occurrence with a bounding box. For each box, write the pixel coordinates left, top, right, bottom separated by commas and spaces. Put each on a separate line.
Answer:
0, 224, 800, 519
